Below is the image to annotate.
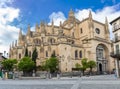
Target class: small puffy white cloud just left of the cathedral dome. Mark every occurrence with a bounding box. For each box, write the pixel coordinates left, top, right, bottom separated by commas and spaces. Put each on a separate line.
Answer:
48, 11, 66, 26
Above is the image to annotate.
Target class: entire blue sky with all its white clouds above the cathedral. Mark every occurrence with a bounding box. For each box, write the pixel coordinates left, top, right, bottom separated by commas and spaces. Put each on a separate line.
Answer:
0, 0, 120, 52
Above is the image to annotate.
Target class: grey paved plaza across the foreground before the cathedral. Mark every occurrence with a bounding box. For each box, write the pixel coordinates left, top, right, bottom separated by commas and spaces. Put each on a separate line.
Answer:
0, 75, 120, 89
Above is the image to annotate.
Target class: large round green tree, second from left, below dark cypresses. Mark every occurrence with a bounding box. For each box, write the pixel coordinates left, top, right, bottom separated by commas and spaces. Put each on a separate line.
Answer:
18, 57, 35, 75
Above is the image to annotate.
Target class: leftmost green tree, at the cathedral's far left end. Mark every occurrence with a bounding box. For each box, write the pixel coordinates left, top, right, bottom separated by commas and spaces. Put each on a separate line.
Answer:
2, 59, 17, 71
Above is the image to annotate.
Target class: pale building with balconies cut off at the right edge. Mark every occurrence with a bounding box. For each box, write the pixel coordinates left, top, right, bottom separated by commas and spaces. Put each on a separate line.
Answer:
110, 16, 120, 77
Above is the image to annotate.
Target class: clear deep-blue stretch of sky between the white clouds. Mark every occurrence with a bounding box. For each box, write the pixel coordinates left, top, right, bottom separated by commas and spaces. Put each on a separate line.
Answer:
12, 0, 120, 28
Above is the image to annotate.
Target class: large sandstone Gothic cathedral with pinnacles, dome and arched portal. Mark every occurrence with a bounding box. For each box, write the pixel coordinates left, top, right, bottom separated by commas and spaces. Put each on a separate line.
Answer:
9, 10, 114, 72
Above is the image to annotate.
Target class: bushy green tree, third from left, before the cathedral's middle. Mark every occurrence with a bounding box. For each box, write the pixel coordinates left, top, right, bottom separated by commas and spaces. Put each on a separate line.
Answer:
44, 57, 58, 73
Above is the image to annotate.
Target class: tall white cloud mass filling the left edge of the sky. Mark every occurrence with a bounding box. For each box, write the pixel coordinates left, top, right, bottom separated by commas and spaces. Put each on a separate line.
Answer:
0, 0, 20, 53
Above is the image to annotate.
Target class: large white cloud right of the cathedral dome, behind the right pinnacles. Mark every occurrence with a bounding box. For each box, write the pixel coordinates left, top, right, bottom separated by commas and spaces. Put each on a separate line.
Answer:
75, 3, 120, 39
